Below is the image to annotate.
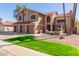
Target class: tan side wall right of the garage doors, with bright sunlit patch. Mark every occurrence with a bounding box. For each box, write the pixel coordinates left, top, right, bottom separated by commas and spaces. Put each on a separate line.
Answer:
35, 13, 45, 33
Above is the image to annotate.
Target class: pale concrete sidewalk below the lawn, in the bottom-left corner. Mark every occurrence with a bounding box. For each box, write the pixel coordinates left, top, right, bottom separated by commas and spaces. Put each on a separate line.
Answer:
0, 40, 48, 56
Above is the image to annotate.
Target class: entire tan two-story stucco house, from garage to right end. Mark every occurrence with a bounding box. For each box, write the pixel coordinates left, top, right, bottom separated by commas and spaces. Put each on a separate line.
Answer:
14, 8, 73, 33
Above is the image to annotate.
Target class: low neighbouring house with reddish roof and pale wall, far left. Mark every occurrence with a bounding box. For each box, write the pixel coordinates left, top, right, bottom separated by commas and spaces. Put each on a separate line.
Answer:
0, 21, 14, 32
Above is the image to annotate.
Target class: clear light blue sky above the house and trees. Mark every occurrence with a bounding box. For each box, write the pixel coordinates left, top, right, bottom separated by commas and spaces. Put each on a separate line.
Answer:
0, 3, 79, 21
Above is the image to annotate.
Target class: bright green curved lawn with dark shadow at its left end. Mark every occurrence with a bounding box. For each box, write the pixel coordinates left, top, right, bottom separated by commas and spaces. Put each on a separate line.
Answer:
5, 35, 79, 56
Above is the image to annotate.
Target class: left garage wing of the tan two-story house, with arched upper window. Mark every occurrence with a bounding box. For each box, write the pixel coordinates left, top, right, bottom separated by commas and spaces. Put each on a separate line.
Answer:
14, 9, 45, 33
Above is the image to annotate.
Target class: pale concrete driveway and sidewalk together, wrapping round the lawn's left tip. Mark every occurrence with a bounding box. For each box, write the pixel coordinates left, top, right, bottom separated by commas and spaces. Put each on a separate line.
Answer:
0, 32, 48, 56
